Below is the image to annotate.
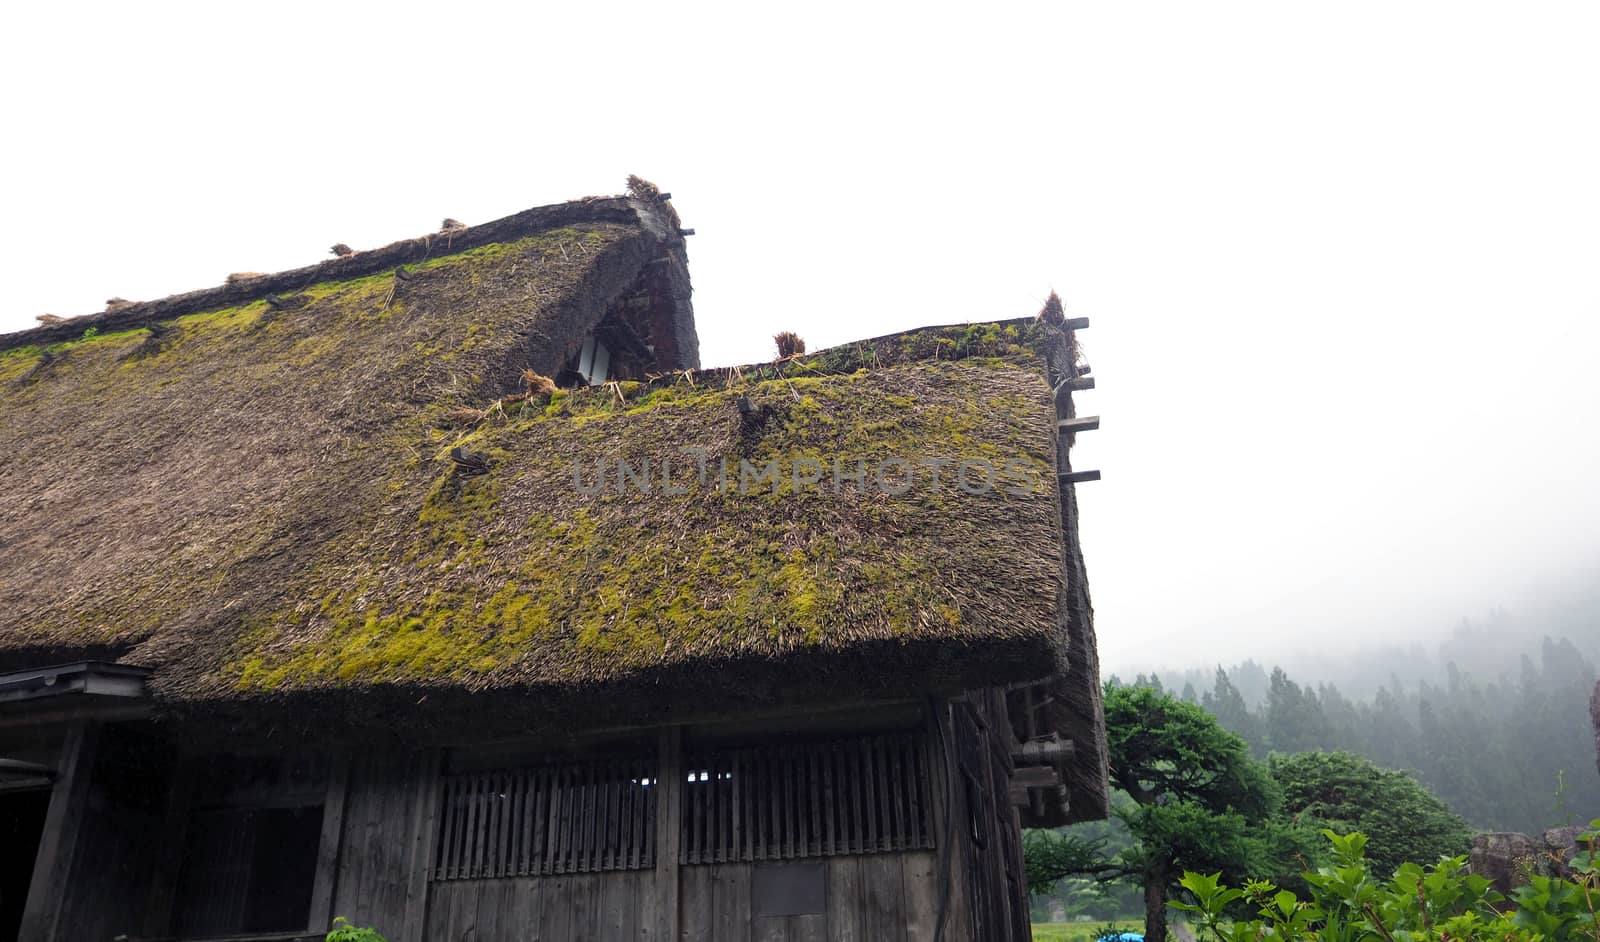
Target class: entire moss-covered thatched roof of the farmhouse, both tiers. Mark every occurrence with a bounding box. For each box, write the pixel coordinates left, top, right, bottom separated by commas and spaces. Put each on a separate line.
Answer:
0, 189, 1098, 786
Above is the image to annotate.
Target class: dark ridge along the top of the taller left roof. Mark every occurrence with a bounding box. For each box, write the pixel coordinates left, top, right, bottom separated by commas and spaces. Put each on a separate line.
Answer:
0, 197, 682, 350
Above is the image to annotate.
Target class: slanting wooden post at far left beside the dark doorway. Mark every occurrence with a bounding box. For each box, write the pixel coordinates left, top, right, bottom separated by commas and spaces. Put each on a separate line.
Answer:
18, 723, 99, 942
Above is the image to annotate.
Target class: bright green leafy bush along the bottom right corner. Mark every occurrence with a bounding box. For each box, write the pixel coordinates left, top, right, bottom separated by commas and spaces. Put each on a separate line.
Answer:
1174, 820, 1600, 942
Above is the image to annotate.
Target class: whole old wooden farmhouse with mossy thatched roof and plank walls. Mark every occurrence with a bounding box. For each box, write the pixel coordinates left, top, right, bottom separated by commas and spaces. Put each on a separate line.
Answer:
0, 179, 1107, 942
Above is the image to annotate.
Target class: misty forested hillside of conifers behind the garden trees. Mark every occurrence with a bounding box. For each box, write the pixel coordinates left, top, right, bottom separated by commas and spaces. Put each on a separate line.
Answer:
1133, 626, 1600, 832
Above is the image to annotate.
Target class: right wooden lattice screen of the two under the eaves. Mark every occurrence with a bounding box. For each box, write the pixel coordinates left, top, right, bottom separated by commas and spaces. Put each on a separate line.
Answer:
680, 736, 933, 864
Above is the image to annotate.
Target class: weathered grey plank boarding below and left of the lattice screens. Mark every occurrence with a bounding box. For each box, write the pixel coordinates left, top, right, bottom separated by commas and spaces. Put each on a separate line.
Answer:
312, 716, 1008, 942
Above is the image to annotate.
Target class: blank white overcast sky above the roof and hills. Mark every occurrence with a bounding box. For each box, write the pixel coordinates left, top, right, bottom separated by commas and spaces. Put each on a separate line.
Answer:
0, 2, 1600, 672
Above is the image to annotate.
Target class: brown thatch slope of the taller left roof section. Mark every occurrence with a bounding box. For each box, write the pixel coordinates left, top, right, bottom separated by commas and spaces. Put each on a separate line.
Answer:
0, 215, 654, 664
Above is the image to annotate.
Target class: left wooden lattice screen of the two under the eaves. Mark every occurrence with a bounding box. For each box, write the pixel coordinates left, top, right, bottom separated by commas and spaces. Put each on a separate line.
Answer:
432, 756, 658, 880
